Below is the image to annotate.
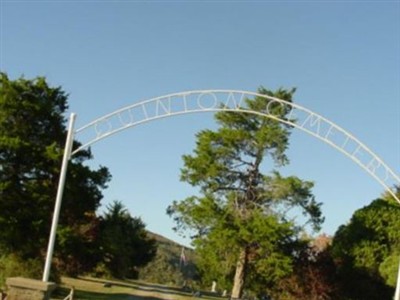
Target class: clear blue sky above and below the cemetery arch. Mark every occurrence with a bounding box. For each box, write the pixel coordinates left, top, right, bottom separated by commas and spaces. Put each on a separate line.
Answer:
0, 0, 400, 244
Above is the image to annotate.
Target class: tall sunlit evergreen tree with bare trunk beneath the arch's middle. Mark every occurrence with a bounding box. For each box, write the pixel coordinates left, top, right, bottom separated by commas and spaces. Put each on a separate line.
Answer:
167, 88, 323, 298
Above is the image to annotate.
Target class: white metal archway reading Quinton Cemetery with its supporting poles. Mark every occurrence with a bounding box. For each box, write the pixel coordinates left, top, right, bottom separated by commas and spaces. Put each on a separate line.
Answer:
43, 90, 400, 300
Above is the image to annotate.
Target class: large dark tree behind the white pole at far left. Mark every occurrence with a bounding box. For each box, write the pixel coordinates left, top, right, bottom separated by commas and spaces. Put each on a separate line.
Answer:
0, 73, 110, 272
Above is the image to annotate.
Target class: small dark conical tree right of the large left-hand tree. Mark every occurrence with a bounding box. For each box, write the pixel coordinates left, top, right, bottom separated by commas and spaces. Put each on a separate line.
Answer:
100, 201, 157, 278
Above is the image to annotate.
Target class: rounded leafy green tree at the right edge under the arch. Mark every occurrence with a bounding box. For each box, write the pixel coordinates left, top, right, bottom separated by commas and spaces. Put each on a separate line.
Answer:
332, 187, 400, 299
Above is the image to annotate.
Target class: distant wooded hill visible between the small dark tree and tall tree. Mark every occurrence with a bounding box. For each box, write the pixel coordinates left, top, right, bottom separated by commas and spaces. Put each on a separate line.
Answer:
139, 231, 198, 286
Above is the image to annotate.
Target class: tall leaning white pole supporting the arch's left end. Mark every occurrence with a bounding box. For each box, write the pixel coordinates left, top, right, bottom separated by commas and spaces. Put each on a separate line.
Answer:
42, 113, 76, 282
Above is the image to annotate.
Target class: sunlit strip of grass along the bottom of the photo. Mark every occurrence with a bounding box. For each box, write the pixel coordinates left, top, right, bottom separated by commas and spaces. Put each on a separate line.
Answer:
52, 277, 221, 300
